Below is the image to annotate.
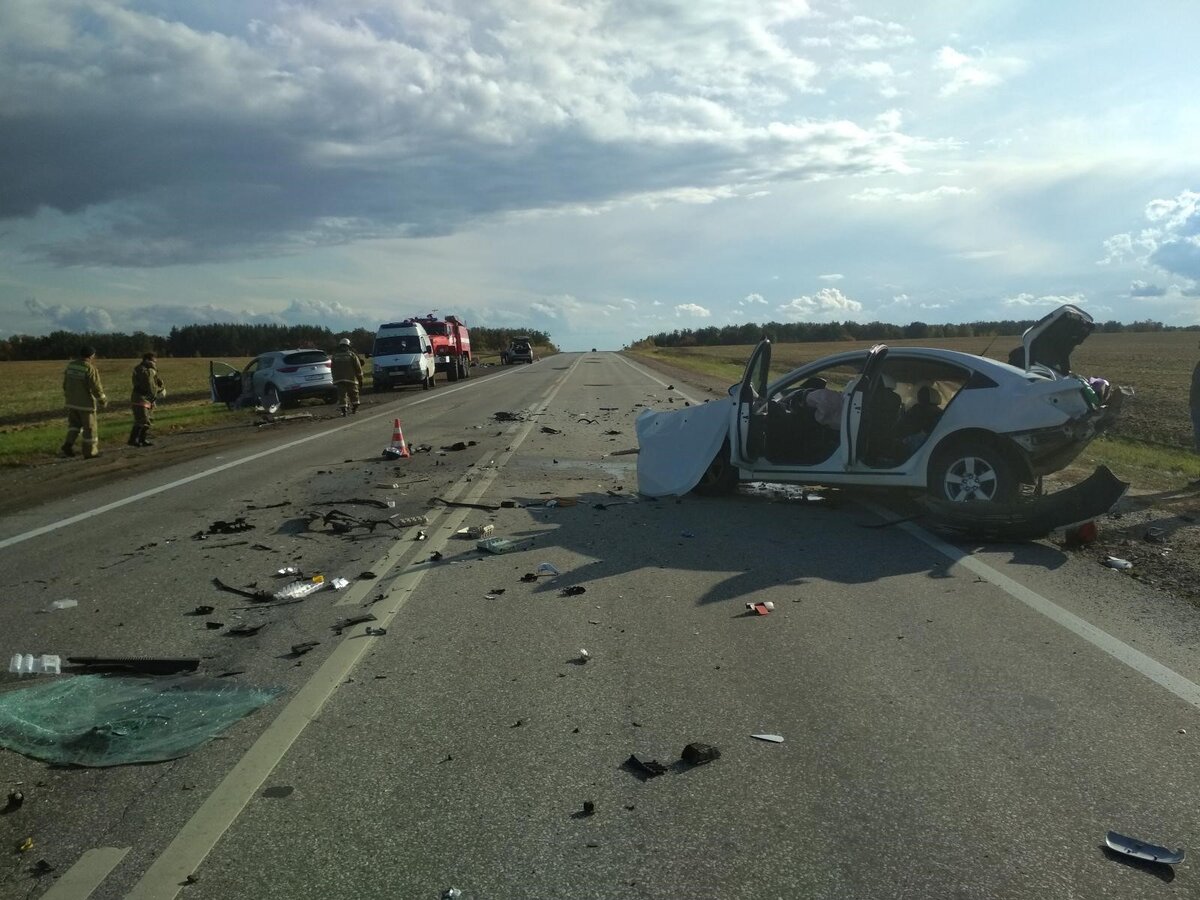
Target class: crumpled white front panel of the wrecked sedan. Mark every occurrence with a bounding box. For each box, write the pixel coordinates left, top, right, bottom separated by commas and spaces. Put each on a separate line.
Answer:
637, 400, 733, 497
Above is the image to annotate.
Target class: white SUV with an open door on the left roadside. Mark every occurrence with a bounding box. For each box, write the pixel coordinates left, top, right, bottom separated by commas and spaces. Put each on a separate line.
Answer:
209, 349, 337, 414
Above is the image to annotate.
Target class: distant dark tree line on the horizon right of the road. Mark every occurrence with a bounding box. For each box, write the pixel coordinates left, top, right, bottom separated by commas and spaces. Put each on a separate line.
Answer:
637, 319, 1200, 347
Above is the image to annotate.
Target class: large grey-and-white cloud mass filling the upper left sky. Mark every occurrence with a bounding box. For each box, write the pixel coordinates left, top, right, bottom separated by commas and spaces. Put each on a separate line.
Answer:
0, 0, 919, 268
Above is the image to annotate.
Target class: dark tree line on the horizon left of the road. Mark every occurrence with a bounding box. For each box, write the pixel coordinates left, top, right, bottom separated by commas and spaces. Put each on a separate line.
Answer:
0, 323, 553, 361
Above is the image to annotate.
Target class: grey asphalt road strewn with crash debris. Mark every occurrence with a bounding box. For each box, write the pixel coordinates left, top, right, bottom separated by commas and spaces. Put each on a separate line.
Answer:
0, 353, 1200, 900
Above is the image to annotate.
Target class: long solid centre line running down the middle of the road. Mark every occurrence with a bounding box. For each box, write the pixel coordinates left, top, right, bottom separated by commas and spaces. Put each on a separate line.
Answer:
126, 358, 582, 900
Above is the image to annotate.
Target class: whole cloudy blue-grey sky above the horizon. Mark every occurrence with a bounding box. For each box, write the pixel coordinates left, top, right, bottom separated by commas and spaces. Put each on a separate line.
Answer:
0, 0, 1200, 349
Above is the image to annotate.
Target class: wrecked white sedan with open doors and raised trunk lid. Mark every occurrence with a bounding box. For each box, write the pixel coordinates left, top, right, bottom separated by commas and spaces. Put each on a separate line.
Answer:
637, 305, 1123, 503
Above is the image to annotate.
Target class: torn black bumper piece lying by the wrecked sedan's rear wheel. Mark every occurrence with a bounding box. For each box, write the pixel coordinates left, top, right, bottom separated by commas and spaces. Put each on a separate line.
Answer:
917, 466, 1129, 541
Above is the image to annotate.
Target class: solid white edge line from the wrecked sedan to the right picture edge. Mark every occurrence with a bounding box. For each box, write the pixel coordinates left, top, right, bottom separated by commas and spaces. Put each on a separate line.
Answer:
883, 504, 1200, 709
